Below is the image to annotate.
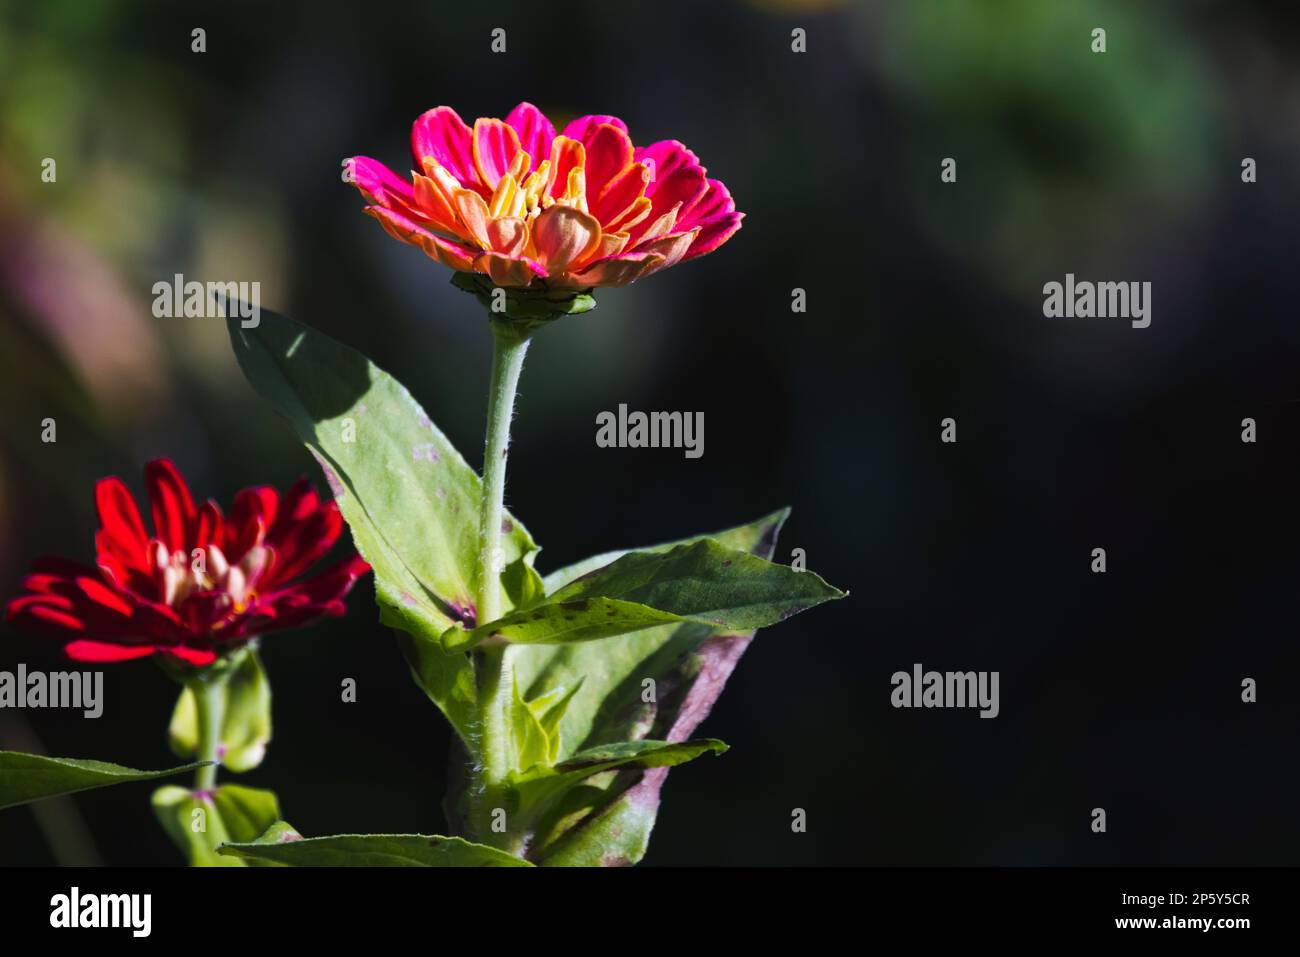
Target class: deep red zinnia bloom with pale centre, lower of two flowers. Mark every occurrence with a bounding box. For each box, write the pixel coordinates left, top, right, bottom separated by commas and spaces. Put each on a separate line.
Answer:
7, 459, 369, 667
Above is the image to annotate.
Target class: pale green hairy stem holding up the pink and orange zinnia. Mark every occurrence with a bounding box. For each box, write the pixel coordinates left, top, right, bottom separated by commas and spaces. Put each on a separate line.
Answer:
476, 322, 528, 798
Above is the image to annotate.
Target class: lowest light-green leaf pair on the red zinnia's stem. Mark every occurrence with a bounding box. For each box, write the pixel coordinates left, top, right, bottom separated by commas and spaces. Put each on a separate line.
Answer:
152, 784, 280, 867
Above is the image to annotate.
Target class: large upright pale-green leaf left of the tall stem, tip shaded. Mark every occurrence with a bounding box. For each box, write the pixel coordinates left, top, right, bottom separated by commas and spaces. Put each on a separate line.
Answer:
228, 309, 540, 742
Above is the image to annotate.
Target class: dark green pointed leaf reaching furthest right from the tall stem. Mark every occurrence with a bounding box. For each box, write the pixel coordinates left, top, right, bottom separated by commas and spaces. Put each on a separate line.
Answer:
442, 538, 844, 651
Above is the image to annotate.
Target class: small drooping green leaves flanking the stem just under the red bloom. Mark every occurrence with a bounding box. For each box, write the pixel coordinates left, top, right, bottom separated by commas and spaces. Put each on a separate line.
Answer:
168, 649, 270, 771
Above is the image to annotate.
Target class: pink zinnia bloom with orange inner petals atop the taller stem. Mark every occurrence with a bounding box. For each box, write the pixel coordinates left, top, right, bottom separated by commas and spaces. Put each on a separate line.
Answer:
345, 103, 744, 289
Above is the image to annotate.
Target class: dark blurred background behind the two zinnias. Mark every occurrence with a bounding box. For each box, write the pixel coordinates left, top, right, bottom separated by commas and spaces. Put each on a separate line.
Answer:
0, 0, 1300, 865
